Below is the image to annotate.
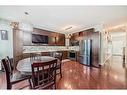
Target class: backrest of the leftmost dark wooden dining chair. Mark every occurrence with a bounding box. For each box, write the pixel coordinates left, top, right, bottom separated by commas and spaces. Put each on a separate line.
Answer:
2, 58, 13, 84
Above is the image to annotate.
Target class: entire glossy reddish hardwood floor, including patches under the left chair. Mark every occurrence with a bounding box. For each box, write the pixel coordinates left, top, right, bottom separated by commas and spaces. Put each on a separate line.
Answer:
0, 56, 127, 89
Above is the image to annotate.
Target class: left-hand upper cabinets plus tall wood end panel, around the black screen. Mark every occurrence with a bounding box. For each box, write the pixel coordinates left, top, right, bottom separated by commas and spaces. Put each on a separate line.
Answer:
13, 28, 65, 67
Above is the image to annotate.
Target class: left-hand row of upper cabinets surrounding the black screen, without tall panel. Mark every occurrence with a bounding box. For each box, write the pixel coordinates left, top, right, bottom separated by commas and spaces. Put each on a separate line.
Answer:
23, 28, 65, 46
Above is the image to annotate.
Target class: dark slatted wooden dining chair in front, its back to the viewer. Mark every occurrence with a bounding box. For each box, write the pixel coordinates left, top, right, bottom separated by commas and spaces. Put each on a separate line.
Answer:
31, 59, 57, 89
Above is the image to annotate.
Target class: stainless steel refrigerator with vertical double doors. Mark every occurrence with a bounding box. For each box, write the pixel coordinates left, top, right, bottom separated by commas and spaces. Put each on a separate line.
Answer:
79, 39, 92, 66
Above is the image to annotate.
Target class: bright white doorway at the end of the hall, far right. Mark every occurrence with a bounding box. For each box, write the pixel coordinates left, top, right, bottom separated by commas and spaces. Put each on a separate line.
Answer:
110, 32, 126, 68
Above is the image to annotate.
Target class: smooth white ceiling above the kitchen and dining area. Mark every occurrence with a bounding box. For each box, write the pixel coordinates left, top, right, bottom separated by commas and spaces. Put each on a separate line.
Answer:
0, 6, 127, 33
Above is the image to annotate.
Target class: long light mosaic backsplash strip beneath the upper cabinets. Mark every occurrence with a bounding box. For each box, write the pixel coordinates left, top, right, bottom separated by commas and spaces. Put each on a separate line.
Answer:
23, 46, 79, 53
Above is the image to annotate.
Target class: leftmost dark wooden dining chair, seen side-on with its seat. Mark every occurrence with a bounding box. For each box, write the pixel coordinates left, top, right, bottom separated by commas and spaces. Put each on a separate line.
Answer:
2, 58, 31, 89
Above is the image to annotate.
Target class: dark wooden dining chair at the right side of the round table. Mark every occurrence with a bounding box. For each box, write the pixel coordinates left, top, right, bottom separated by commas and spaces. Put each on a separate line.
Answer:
52, 52, 63, 78
